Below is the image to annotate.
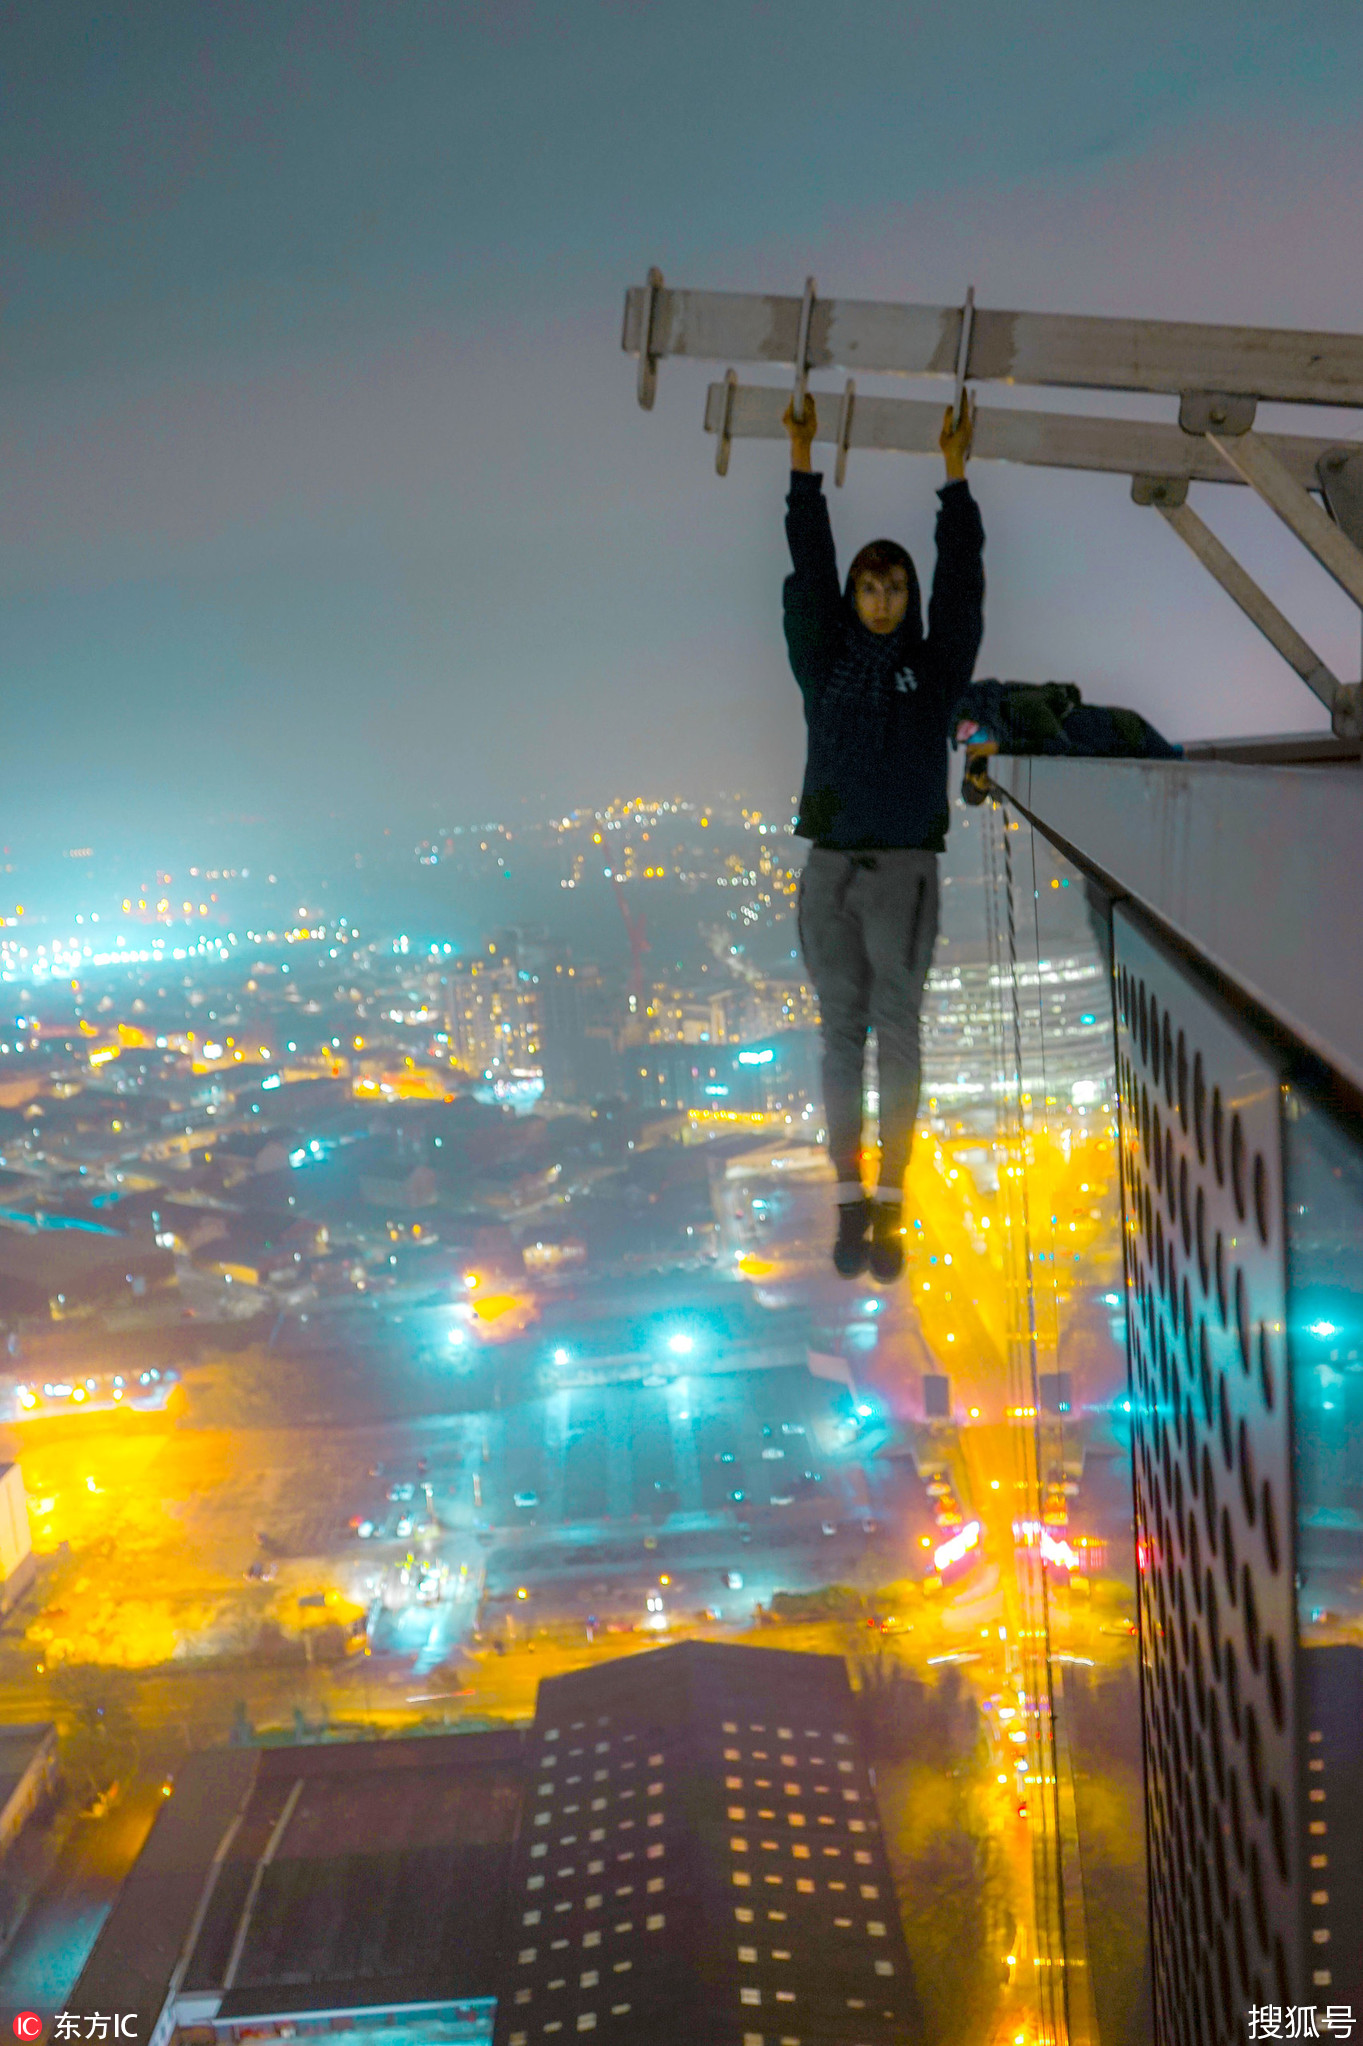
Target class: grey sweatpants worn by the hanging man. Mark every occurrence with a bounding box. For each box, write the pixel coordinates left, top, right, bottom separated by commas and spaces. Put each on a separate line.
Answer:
800, 845, 937, 1193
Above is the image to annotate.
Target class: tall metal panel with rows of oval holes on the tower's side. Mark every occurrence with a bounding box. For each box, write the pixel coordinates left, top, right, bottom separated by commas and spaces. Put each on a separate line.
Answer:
1113, 908, 1302, 2046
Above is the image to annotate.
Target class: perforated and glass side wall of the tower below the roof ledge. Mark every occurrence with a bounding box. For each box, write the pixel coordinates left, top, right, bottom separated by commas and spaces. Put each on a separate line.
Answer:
1113, 908, 1363, 2046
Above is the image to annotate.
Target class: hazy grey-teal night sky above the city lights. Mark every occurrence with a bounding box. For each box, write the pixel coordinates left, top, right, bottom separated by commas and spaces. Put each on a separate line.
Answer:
0, 0, 1363, 845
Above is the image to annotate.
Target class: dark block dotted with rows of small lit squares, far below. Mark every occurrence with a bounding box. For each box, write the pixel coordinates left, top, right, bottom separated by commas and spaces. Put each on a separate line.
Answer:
495, 1641, 921, 2046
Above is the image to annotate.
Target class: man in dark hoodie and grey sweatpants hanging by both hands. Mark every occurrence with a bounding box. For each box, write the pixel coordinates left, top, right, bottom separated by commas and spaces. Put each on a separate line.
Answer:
784, 393, 984, 1283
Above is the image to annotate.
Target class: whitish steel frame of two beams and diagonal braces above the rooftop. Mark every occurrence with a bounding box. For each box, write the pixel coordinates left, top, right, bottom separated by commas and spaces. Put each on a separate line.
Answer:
622, 270, 1363, 739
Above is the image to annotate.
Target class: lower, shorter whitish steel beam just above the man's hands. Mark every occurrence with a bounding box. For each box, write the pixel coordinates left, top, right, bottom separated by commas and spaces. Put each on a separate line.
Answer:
706, 381, 1338, 488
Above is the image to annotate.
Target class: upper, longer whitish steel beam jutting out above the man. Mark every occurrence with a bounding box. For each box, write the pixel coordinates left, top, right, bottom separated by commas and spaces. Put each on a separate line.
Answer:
622, 282, 1363, 405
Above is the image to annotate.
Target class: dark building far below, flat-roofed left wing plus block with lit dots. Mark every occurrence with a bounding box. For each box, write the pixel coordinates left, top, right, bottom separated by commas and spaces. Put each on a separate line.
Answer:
70, 1641, 921, 2046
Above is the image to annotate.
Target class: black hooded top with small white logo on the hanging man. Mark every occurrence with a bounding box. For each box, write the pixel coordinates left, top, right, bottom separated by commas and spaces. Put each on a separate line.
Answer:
784, 471, 984, 853
